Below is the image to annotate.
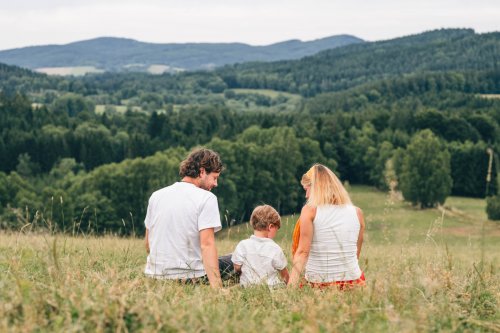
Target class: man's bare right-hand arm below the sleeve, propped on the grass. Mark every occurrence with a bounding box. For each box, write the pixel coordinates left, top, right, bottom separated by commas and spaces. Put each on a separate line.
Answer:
200, 228, 222, 288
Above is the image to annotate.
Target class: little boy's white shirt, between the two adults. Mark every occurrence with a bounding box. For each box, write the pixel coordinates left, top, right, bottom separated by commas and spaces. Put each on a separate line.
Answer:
231, 235, 287, 286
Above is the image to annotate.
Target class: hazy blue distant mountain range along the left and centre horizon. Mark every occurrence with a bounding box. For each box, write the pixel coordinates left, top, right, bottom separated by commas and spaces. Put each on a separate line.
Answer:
0, 35, 364, 74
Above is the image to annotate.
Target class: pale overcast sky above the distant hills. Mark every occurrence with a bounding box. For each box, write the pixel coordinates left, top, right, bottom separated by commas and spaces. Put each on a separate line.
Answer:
0, 0, 500, 50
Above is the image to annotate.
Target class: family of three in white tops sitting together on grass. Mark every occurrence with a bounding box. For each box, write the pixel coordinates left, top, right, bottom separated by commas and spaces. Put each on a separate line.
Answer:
145, 148, 365, 289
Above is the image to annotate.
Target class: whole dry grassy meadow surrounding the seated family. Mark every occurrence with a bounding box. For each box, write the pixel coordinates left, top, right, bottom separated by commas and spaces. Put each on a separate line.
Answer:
0, 187, 500, 332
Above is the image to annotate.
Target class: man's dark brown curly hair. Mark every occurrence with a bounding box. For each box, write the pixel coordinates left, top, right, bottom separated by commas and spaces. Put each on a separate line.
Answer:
179, 148, 224, 178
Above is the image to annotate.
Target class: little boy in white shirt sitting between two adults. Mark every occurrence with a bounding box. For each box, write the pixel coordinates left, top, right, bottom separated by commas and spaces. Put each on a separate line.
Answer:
231, 205, 288, 287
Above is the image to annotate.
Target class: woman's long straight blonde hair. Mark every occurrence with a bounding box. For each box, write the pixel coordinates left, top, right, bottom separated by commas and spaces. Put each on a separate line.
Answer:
300, 164, 352, 207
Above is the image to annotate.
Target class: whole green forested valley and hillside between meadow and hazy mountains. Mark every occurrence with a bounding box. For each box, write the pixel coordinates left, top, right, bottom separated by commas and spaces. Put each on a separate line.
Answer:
0, 29, 500, 235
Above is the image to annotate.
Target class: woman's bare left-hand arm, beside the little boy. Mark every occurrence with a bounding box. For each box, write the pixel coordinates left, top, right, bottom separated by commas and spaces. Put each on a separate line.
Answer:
288, 205, 316, 286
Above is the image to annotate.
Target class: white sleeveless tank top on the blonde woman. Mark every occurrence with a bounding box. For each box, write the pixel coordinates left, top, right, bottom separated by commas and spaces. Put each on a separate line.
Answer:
305, 205, 361, 282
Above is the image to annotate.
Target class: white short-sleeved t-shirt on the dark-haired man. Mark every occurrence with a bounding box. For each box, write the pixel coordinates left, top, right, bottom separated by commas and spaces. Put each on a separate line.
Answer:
144, 182, 222, 279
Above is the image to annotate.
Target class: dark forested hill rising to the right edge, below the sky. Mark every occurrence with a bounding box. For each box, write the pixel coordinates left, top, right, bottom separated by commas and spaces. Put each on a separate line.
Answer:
218, 29, 500, 96
